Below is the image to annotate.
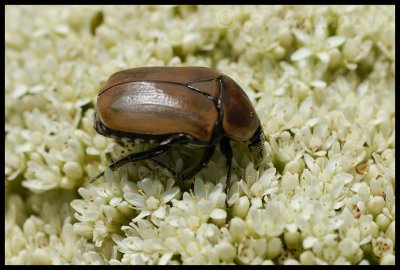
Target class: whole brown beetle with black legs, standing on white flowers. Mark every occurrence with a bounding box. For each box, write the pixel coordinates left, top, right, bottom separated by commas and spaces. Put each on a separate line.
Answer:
94, 67, 264, 187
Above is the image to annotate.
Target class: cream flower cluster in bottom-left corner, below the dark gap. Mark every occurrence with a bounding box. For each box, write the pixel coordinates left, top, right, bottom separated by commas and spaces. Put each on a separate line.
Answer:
5, 192, 98, 264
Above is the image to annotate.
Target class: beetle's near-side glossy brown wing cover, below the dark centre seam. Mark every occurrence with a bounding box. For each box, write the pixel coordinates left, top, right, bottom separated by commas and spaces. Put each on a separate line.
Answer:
98, 79, 218, 142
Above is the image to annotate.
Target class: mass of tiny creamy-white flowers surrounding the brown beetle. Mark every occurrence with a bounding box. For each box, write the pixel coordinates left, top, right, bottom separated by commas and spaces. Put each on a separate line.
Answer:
5, 6, 395, 265
